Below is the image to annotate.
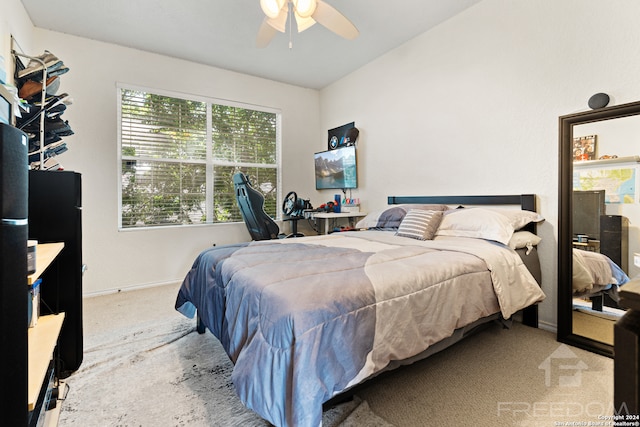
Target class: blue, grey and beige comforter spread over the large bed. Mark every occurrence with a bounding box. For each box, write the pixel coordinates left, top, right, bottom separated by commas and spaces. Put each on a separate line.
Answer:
176, 232, 544, 426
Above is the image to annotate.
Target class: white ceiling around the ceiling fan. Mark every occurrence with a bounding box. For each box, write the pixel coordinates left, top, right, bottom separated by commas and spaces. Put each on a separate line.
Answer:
22, 0, 480, 89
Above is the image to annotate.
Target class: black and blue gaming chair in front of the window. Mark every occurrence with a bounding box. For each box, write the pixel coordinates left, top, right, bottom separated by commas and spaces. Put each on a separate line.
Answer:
233, 172, 284, 240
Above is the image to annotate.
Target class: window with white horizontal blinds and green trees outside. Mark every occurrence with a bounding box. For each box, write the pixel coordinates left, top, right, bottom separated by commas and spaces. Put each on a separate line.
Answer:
118, 87, 280, 228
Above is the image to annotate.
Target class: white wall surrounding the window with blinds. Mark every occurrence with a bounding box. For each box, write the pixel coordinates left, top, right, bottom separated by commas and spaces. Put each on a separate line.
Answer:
8, 29, 320, 294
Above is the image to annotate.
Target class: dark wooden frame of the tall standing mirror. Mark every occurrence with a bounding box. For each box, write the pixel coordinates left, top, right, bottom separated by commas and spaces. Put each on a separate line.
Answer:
557, 101, 640, 357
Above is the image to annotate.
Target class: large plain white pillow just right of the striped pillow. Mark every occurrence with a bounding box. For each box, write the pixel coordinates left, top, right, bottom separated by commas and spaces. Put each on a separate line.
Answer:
436, 208, 514, 245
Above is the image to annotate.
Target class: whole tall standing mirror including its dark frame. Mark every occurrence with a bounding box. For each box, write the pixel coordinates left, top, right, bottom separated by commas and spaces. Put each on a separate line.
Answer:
558, 103, 640, 356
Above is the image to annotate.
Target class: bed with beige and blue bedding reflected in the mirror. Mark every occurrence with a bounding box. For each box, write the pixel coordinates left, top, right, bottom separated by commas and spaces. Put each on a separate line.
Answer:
572, 248, 630, 311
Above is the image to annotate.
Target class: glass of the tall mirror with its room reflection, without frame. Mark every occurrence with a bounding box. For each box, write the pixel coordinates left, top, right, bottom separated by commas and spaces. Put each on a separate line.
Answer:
572, 116, 640, 345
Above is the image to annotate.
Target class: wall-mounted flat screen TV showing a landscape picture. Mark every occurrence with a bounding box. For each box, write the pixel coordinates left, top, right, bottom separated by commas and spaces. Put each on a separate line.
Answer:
314, 145, 358, 190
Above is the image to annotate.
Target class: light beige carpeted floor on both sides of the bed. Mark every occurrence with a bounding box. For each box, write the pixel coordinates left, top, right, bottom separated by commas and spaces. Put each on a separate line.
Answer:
60, 285, 614, 427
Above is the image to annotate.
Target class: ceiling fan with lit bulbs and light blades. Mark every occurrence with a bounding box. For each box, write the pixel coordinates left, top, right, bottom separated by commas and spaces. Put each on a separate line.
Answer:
256, 0, 360, 48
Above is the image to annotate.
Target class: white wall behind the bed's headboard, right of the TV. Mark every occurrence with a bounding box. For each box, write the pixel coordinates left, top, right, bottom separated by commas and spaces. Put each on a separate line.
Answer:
321, 0, 640, 326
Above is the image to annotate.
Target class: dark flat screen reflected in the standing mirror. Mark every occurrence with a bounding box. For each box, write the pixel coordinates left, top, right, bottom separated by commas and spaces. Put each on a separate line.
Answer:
572, 190, 606, 240
